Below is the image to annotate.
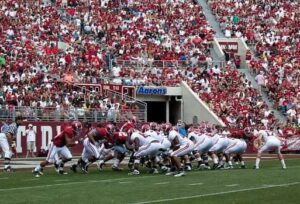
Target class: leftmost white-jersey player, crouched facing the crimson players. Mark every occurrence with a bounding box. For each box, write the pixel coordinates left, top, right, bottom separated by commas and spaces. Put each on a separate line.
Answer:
126, 129, 162, 175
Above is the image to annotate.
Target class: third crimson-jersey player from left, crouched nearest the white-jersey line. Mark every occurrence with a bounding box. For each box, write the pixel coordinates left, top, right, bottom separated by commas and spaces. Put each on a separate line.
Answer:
98, 132, 127, 171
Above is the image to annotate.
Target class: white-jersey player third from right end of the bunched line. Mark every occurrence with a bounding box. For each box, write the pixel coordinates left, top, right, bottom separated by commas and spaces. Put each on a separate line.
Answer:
188, 128, 213, 169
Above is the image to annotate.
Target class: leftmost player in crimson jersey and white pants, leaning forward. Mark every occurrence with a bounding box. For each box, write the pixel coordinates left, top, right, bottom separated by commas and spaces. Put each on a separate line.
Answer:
32, 121, 82, 177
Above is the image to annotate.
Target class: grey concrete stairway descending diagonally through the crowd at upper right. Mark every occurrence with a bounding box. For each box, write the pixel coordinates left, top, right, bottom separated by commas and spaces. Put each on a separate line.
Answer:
197, 0, 287, 123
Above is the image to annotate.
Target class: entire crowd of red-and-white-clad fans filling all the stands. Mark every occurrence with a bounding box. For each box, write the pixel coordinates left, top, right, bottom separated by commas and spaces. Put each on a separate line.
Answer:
0, 0, 300, 135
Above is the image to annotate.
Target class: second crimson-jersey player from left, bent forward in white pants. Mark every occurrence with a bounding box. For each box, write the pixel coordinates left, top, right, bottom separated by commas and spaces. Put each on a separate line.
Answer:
71, 123, 112, 173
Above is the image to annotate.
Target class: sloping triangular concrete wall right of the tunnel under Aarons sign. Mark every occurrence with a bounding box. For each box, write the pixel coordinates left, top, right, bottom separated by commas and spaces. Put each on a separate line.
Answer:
181, 82, 225, 126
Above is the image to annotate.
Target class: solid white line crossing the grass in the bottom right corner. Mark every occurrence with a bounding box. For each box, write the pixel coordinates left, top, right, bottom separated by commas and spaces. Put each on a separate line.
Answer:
131, 182, 300, 204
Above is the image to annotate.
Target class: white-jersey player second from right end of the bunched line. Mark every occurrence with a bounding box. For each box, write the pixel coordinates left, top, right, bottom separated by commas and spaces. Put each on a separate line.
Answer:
209, 126, 229, 169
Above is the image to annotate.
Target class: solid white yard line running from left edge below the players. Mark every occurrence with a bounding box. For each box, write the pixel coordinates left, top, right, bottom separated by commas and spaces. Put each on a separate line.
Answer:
0, 176, 153, 192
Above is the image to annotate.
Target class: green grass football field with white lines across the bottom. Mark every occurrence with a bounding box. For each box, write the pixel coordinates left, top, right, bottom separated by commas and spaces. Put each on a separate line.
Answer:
0, 159, 300, 204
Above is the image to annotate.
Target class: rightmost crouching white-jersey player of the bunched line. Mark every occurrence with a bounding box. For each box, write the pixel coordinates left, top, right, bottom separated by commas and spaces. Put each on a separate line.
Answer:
224, 138, 247, 169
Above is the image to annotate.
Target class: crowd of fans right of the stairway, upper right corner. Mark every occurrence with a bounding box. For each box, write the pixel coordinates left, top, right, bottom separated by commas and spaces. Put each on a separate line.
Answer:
208, 0, 300, 129
